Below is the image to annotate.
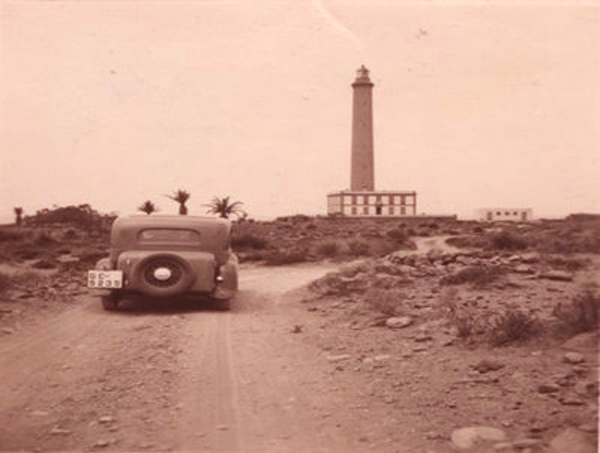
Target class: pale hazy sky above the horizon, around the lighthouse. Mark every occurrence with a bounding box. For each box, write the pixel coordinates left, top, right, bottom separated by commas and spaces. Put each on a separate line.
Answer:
0, 0, 600, 222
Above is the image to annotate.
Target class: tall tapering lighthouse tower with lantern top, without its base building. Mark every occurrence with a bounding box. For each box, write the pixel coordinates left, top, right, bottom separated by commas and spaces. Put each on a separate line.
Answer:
350, 65, 375, 192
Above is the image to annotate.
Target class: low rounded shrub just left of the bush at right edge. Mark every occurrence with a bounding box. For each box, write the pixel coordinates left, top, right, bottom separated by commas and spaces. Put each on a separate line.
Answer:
488, 309, 541, 346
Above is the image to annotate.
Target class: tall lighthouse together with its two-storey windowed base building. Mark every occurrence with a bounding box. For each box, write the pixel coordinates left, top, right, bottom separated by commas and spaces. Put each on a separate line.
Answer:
327, 65, 417, 217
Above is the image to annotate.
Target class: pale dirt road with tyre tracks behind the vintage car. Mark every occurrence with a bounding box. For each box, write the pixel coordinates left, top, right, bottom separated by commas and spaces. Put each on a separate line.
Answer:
0, 265, 372, 452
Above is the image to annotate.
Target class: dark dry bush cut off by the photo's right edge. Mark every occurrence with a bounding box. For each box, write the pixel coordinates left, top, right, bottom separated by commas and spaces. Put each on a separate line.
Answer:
552, 285, 600, 335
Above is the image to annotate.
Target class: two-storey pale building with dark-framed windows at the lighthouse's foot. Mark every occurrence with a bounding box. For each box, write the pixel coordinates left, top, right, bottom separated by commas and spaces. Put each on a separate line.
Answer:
327, 191, 417, 217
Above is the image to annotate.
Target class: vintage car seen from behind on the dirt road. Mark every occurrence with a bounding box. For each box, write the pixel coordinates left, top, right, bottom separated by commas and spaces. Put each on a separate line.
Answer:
88, 215, 238, 310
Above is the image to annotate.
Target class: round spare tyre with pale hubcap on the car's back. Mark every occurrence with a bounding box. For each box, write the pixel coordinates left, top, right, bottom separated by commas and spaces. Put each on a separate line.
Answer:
137, 254, 194, 297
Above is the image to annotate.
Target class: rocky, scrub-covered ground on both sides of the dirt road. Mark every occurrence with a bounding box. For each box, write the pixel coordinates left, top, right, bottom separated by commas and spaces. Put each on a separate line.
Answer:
0, 213, 600, 453
